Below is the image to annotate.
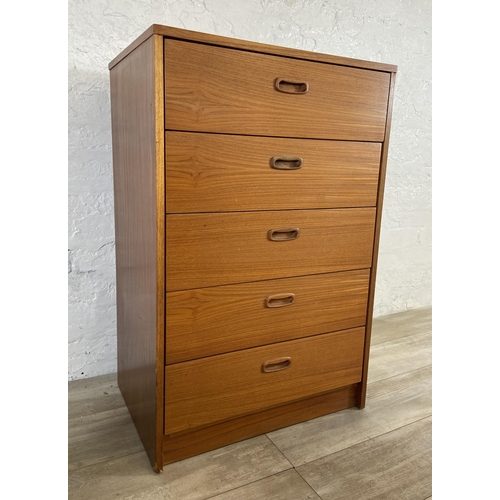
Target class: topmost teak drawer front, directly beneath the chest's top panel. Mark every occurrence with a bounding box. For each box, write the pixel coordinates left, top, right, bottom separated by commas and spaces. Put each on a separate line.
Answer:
165, 39, 390, 142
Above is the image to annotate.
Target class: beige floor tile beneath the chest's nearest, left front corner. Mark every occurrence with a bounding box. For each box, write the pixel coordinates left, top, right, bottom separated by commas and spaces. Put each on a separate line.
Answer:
69, 436, 291, 500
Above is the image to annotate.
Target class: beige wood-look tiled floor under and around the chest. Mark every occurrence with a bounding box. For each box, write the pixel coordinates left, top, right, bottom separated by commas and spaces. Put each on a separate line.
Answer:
69, 307, 432, 500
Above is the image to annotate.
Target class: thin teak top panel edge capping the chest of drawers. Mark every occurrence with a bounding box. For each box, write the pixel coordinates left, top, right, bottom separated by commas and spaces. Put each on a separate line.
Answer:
109, 24, 397, 72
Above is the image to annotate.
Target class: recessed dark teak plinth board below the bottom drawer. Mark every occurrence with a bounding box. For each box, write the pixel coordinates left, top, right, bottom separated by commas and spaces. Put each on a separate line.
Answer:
163, 385, 356, 464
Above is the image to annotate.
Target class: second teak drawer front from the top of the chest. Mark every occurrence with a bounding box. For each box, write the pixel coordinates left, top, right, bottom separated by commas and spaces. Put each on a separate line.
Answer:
165, 132, 381, 213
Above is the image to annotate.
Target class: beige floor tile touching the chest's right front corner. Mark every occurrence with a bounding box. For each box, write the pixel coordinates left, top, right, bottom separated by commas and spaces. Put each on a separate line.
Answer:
268, 367, 432, 466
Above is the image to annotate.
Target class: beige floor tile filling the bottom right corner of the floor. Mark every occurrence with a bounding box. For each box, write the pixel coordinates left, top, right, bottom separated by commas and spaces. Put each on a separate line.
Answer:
297, 417, 432, 500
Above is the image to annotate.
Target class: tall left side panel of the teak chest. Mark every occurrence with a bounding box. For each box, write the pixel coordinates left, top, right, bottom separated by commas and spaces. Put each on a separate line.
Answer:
110, 34, 164, 468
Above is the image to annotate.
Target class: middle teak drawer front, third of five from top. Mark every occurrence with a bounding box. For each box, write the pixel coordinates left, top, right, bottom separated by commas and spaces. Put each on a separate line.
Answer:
166, 208, 375, 291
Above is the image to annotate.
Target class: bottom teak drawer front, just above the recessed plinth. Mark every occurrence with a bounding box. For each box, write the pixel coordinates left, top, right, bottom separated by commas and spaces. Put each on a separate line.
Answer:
165, 328, 365, 434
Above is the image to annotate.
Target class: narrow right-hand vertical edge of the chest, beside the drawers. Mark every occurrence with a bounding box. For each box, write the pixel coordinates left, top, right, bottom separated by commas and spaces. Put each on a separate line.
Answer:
357, 74, 396, 409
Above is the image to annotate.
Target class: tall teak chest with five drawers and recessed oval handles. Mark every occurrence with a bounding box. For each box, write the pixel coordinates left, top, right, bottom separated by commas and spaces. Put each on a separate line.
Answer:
109, 25, 396, 471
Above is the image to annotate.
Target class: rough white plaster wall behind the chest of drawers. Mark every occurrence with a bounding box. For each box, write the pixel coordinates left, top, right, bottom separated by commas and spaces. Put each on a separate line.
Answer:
68, 0, 431, 380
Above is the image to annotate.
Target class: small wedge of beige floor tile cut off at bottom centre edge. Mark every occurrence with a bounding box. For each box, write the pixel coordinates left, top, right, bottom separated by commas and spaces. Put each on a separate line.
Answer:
207, 470, 321, 500
